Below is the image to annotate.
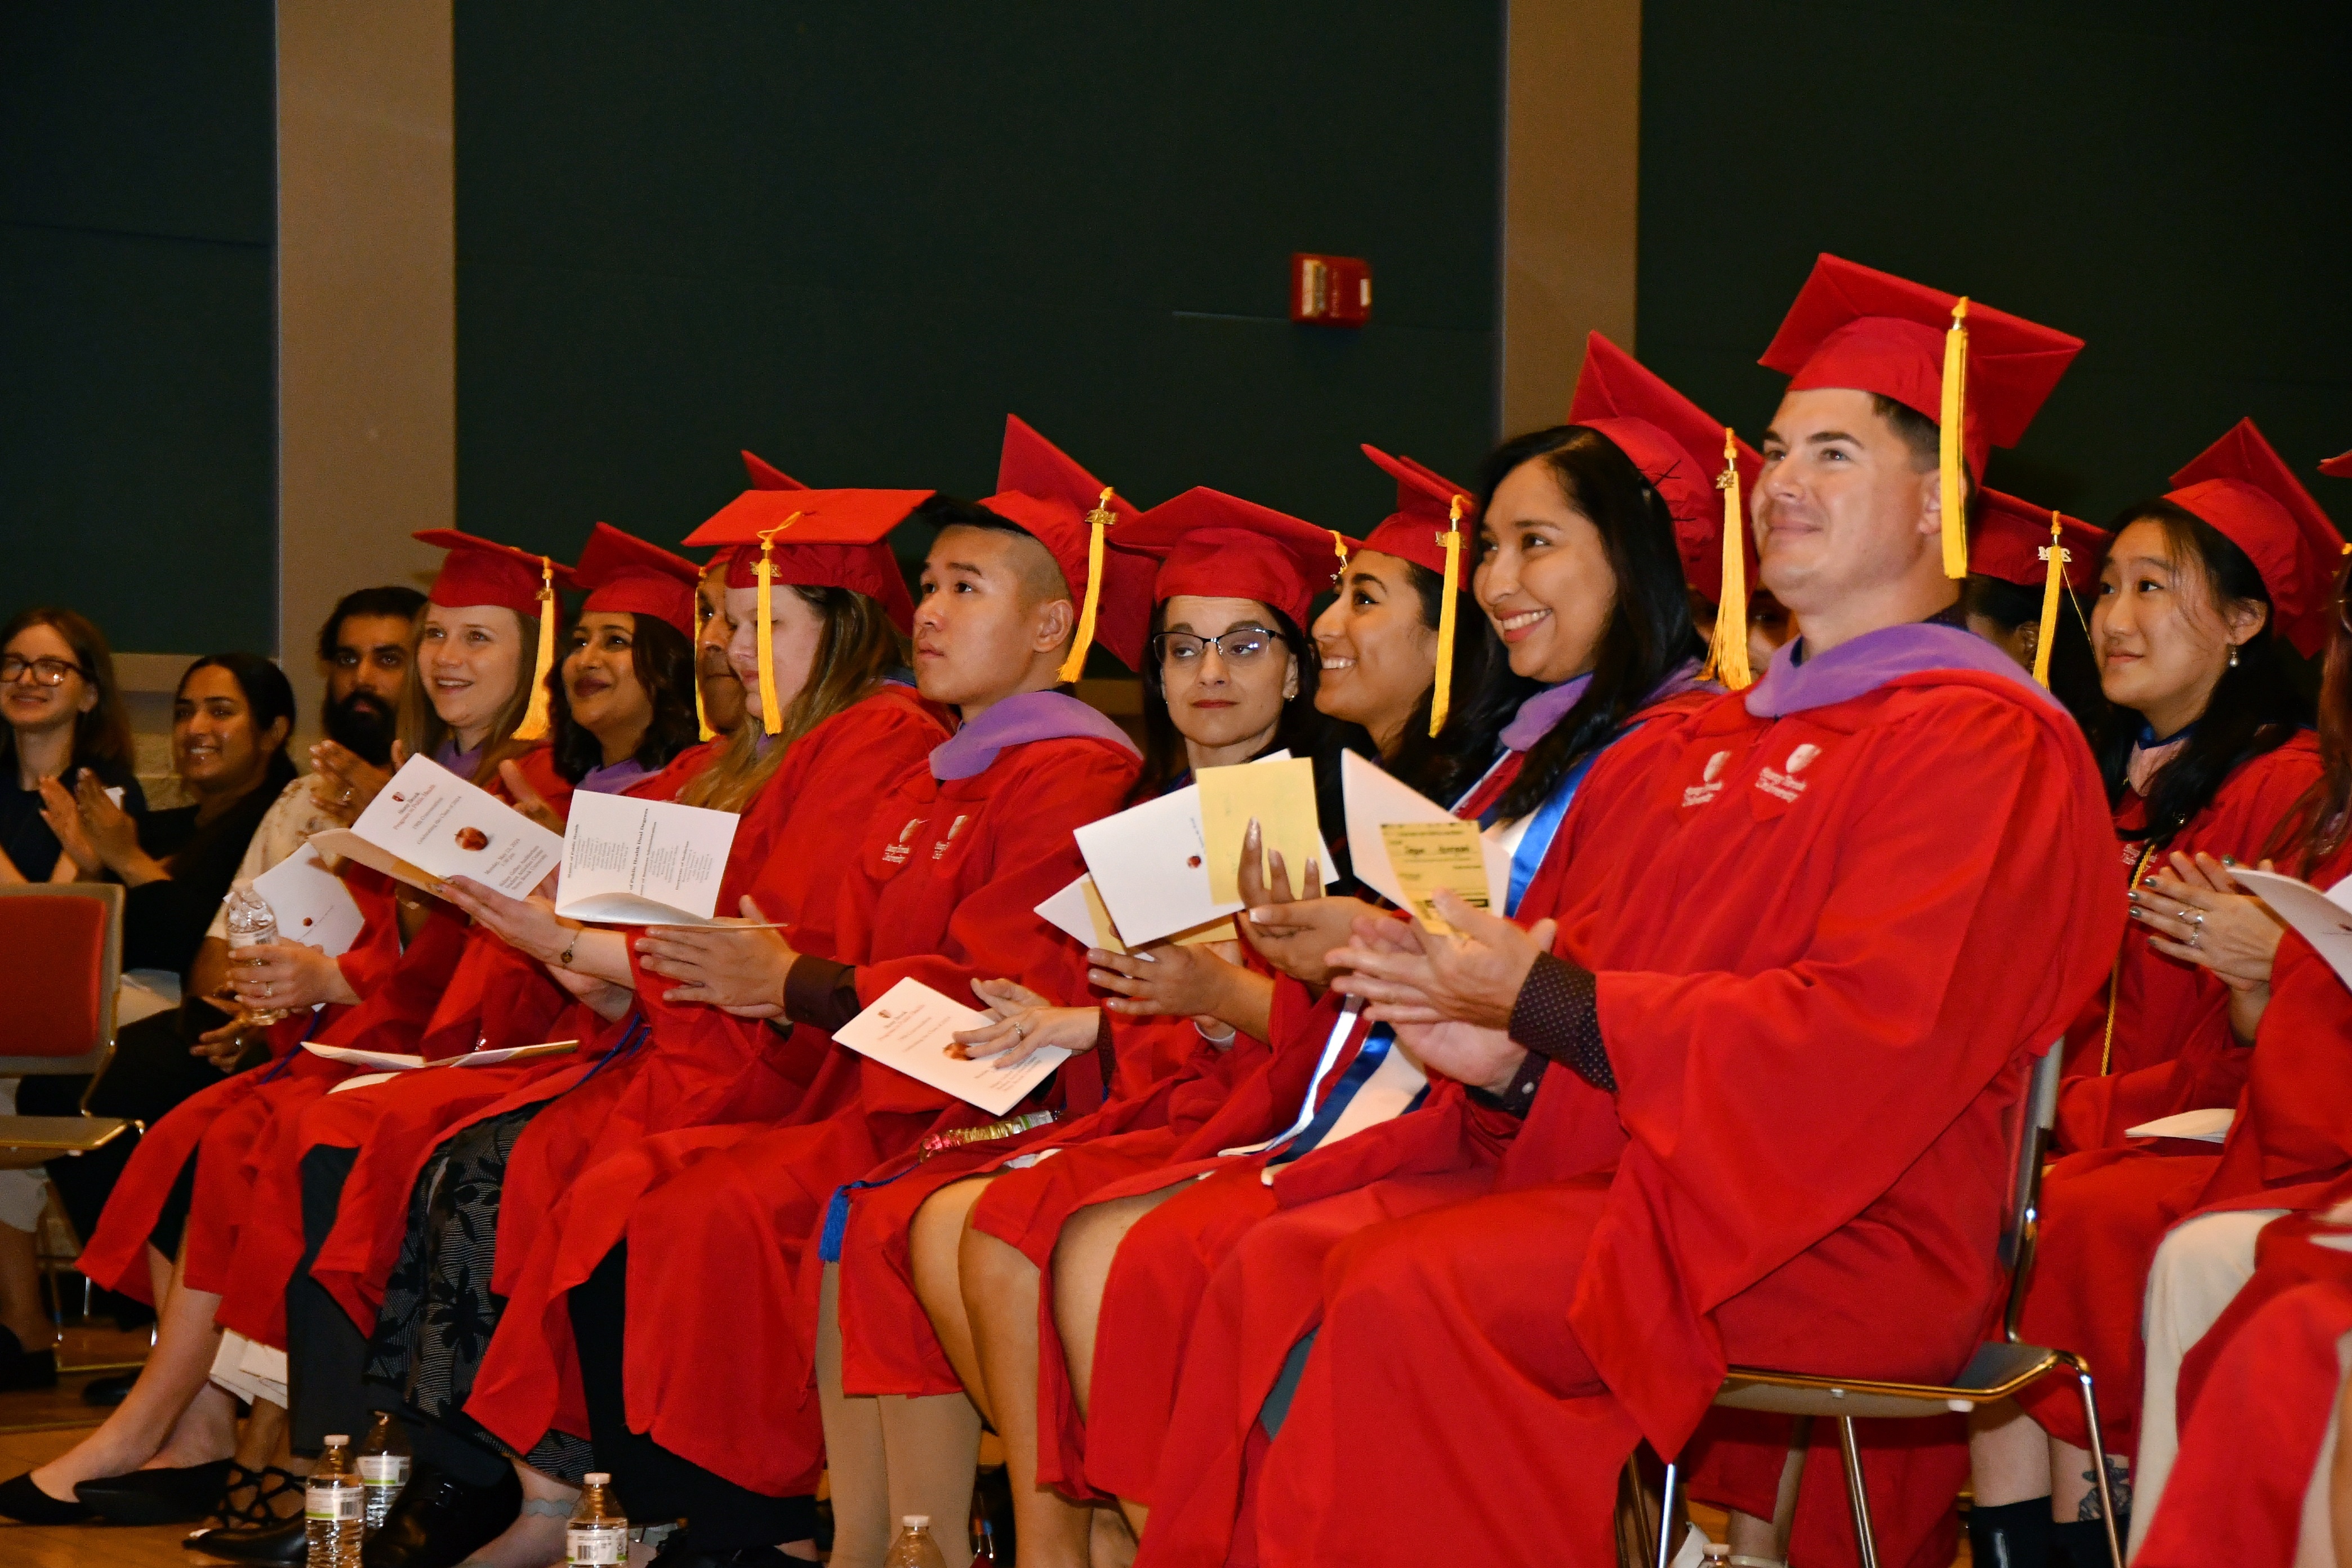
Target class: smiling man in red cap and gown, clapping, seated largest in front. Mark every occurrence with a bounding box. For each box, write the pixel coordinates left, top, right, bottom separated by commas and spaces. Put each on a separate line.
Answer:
1241, 256, 2122, 1568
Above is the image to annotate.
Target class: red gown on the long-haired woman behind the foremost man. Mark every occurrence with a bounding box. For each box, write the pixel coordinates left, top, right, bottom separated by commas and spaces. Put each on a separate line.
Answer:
2056, 733, 2319, 1152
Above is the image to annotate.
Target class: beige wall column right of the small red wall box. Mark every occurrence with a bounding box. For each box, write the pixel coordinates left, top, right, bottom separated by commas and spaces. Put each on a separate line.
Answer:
1500, 0, 1642, 435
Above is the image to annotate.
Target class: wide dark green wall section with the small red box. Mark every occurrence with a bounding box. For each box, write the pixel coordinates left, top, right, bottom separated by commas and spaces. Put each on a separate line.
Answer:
456, 0, 1500, 602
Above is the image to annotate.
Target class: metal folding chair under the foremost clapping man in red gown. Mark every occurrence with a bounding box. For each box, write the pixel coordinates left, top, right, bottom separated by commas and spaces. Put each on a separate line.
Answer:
1658, 1041, 2124, 1568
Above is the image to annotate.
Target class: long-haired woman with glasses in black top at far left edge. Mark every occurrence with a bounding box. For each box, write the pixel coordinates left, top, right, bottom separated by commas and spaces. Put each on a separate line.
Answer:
0, 609, 146, 884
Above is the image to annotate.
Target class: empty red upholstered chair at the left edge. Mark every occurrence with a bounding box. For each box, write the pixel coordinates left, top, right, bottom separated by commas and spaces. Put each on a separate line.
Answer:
0, 881, 130, 1166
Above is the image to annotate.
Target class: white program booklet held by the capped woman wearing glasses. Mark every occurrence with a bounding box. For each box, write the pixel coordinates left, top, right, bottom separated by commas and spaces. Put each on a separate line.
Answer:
1077, 752, 1331, 947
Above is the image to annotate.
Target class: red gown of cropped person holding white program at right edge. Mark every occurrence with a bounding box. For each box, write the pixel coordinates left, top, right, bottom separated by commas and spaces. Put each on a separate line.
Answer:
2020, 849, 2352, 1455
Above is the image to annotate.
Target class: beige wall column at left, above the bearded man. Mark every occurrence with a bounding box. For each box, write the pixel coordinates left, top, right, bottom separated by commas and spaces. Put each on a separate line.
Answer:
278, 0, 456, 736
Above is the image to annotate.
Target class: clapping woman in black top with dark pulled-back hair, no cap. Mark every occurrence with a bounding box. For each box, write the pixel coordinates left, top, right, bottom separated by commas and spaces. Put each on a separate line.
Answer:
42, 653, 294, 978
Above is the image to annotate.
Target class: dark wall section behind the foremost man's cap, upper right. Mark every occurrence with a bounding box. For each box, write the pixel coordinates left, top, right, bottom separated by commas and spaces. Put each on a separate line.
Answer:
1640, 0, 2352, 522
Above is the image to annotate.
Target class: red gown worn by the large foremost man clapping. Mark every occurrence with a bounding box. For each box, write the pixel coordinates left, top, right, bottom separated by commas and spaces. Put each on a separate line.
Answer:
1251, 670, 2122, 1568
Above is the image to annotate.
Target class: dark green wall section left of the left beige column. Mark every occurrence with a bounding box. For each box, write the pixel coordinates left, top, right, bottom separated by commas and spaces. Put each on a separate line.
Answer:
0, 0, 278, 653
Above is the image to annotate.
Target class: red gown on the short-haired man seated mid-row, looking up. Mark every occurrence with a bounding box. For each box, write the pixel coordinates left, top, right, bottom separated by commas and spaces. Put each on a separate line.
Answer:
468, 733, 1138, 1495
